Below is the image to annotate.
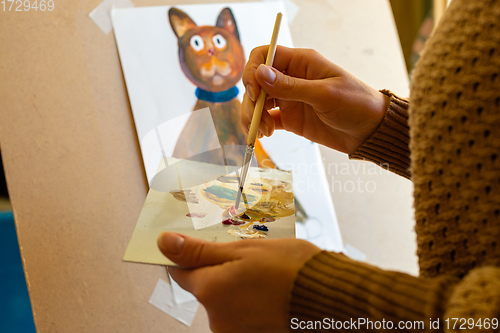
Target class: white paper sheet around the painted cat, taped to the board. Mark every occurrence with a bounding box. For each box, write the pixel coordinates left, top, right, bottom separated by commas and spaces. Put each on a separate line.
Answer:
112, 1, 343, 251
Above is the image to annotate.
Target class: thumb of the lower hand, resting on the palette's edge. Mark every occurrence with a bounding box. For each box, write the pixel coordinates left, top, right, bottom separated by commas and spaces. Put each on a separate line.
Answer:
158, 232, 233, 268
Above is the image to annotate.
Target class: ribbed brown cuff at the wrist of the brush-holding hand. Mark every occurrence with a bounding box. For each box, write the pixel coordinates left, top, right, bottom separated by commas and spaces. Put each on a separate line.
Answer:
349, 90, 410, 179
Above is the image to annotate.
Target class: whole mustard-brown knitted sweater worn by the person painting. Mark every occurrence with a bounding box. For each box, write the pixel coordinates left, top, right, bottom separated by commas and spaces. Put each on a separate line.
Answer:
289, 0, 500, 332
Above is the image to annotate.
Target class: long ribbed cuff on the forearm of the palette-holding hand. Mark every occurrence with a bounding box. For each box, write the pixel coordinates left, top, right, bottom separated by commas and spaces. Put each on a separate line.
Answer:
289, 251, 455, 332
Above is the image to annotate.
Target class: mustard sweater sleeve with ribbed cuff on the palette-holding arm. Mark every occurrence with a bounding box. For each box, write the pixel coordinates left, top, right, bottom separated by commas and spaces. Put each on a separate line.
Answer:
289, 251, 500, 333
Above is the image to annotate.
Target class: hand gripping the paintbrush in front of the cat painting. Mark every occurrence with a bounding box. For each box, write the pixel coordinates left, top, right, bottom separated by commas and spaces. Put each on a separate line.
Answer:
241, 46, 389, 154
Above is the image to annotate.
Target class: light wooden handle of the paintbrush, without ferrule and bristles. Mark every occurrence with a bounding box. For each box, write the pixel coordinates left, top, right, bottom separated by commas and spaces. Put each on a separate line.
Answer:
247, 13, 283, 147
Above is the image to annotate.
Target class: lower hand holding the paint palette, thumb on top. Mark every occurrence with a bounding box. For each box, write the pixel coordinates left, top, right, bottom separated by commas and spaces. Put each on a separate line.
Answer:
158, 232, 321, 333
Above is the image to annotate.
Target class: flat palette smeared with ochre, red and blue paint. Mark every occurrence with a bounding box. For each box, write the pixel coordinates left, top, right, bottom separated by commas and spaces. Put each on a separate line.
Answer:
123, 158, 295, 265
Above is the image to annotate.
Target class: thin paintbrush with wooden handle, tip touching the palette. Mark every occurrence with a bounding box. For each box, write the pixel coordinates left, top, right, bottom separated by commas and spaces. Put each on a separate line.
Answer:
234, 13, 283, 209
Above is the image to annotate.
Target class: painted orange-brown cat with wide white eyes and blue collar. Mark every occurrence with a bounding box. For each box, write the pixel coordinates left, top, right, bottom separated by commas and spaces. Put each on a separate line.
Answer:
168, 7, 275, 167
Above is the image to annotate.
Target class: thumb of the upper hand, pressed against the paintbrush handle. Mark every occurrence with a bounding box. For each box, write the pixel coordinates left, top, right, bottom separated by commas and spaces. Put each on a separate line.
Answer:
255, 65, 318, 103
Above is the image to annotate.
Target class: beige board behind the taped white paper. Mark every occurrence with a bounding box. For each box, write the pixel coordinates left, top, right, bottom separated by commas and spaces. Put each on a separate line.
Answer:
0, 0, 416, 333
